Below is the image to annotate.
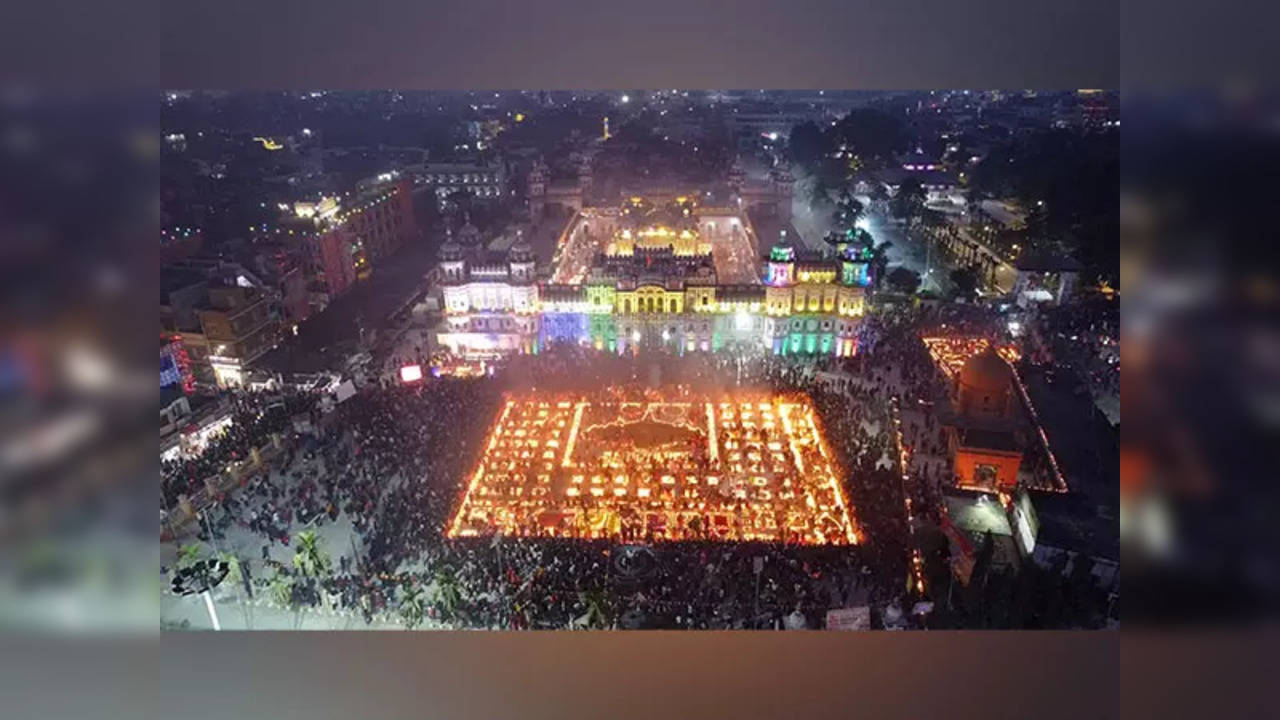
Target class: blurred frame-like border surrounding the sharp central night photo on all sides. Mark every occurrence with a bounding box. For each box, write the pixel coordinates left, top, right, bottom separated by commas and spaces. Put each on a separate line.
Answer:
24, 0, 1277, 717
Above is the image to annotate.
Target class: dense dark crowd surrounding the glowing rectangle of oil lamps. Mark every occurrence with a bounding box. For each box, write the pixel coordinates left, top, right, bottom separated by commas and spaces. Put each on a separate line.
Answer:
165, 302, 1008, 628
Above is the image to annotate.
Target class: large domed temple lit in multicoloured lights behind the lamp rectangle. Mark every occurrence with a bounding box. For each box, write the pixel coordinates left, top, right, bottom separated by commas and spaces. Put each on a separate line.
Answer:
439, 193, 872, 357
